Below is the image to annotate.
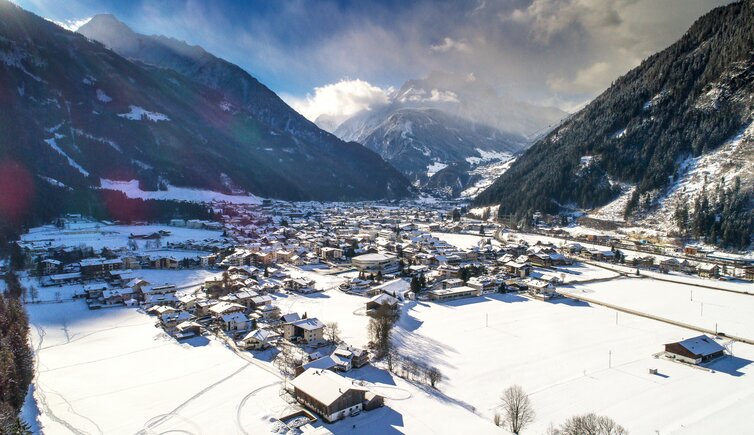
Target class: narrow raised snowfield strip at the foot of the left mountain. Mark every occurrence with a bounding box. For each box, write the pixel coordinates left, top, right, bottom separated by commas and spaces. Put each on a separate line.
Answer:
100, 178, 262, 204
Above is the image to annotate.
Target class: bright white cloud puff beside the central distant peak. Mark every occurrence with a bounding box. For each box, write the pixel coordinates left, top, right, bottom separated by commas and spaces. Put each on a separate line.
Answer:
283, 79, 392, 130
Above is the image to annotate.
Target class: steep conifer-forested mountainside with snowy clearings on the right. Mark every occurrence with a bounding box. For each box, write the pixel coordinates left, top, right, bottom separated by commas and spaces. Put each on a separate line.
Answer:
475, 0, 754, 248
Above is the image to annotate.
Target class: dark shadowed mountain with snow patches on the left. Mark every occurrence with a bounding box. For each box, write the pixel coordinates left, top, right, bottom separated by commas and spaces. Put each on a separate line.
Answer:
0, 0, 410, 209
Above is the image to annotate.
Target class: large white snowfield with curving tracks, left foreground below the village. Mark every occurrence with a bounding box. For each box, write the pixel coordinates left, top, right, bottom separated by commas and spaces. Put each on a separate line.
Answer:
28, 301, 287, 434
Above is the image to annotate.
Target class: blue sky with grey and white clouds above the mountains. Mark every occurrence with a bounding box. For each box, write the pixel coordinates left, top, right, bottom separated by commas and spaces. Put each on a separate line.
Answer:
14, 0, 729, 124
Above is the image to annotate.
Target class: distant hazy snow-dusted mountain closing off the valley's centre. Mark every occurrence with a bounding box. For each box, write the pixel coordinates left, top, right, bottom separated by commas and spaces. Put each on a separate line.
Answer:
332, 73, 565, 192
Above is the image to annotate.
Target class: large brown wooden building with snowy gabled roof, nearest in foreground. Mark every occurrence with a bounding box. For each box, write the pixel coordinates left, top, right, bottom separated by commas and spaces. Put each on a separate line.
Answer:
291, 368, 379, 423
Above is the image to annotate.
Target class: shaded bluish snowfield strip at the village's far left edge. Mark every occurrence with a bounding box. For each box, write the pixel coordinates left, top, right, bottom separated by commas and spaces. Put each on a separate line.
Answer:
21, 222, 222, 250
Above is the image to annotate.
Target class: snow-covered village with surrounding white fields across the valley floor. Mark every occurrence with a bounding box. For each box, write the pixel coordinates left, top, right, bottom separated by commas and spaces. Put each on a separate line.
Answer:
1, 192, 754, 434
